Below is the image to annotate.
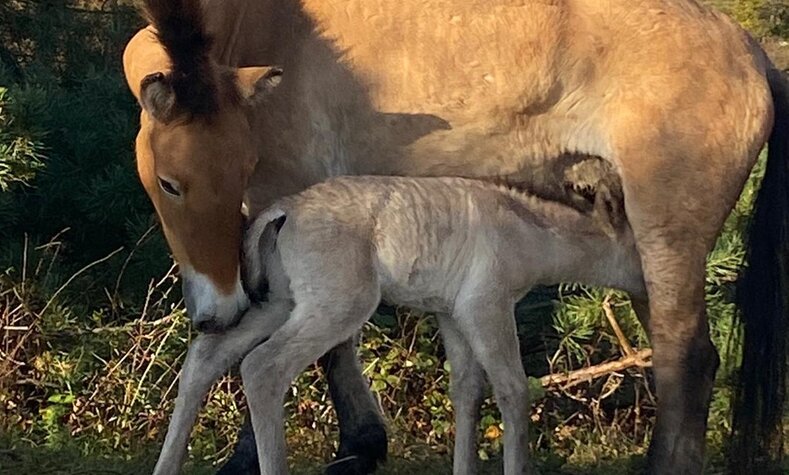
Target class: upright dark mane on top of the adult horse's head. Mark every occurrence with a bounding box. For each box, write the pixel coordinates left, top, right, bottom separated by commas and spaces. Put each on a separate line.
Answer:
143, 0, 219, 115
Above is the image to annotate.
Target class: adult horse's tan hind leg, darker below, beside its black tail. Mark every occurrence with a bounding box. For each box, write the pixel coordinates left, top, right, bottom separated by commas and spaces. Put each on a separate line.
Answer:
617, 130, 758, 474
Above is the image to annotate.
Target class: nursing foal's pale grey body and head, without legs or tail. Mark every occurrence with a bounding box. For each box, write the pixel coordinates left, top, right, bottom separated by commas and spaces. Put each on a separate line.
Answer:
278, 177, 641, 312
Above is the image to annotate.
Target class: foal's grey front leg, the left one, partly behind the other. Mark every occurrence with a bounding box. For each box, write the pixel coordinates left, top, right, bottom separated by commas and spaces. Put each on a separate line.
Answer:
438, 314, 485, 475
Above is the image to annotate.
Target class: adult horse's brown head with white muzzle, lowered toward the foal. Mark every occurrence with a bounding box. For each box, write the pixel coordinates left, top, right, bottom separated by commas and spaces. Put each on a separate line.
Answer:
124, 0, 282, 331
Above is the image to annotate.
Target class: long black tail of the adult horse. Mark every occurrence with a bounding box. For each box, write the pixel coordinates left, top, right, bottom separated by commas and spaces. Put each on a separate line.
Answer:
731, 69, 789, 473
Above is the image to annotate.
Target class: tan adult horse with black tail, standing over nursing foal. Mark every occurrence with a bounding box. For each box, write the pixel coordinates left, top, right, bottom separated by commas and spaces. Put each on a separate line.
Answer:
124, 0, 789, 474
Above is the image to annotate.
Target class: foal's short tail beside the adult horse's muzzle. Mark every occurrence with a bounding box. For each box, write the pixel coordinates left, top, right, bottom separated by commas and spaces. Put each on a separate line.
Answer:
241, 208, 285, 301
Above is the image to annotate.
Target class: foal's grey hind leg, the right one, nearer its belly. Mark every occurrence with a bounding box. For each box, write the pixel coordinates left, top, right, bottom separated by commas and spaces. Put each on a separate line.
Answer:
241, 290, 379, 475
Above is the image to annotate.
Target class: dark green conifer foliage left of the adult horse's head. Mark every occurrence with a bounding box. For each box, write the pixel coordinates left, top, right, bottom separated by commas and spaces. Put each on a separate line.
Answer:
0, 0, 162, 304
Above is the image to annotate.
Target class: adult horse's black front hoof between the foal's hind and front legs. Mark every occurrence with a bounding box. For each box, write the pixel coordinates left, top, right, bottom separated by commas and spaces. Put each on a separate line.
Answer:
326, 425, 388, 475
